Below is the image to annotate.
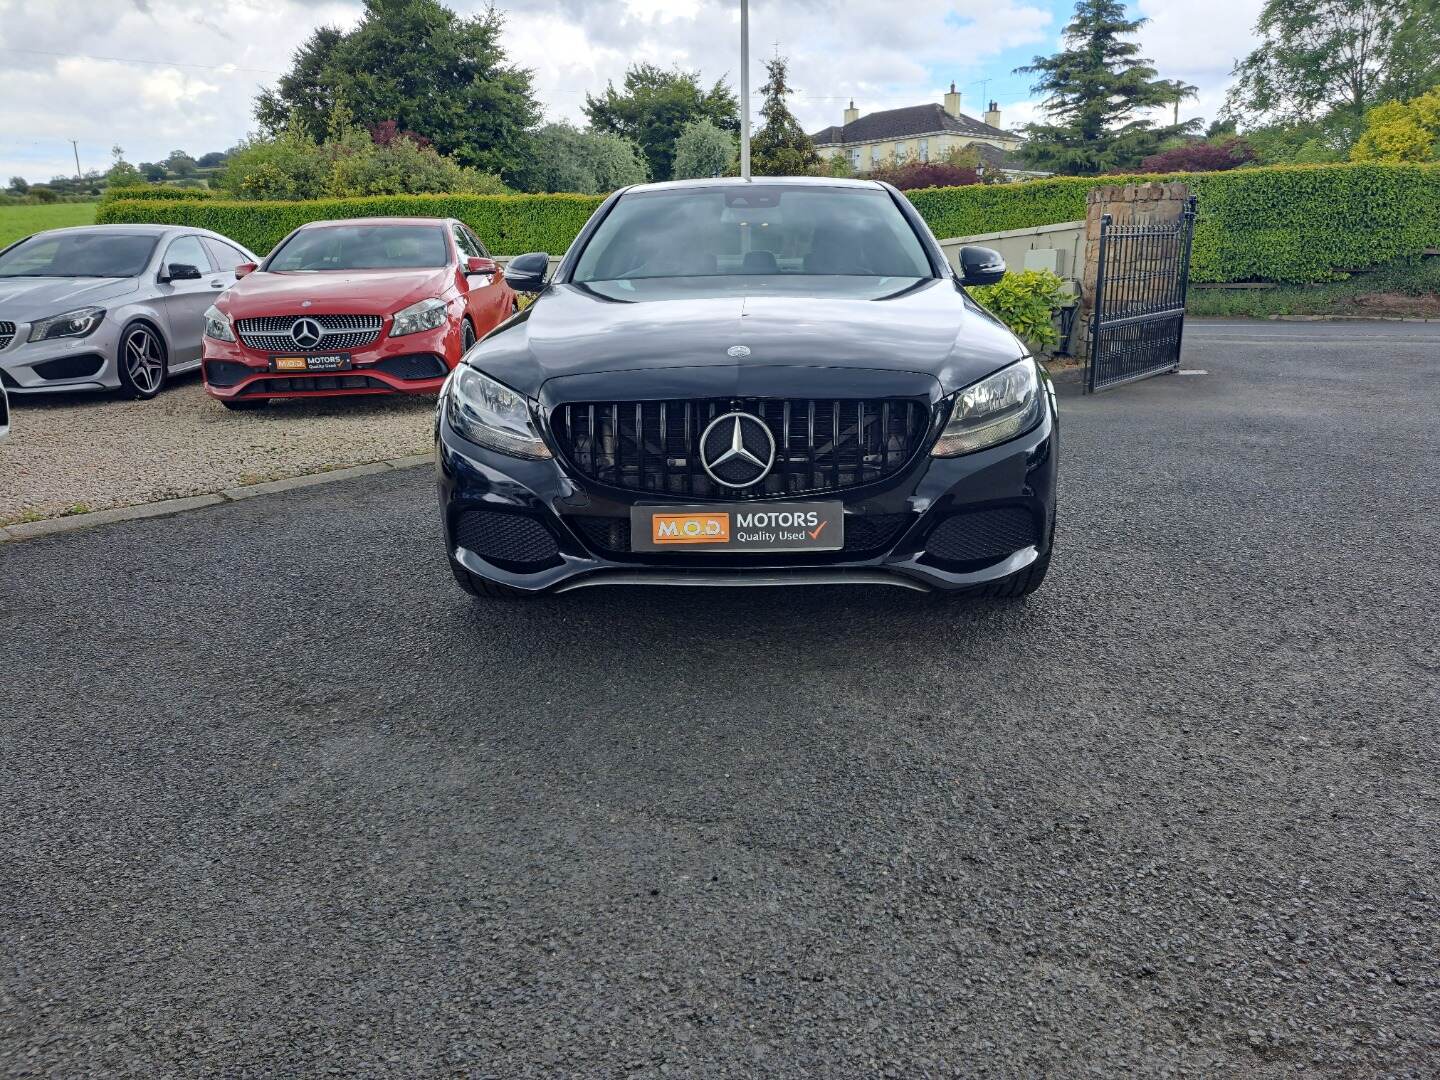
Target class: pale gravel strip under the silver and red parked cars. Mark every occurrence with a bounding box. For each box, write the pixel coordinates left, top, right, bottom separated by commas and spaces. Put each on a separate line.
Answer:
0, 376, 435, 524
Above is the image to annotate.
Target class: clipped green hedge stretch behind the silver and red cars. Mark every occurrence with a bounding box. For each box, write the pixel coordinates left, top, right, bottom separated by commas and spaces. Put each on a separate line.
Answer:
95, 194, 603, 255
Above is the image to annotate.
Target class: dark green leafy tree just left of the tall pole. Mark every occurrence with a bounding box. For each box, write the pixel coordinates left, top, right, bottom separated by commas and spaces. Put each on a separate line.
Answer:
585, 63, 740, 180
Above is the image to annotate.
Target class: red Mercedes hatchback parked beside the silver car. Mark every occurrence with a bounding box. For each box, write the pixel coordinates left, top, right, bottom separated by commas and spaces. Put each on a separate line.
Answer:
203, 217, 516, 409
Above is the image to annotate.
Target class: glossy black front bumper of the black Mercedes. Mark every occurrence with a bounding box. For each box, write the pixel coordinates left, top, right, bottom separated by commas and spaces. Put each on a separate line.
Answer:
436, 400, 1057, 592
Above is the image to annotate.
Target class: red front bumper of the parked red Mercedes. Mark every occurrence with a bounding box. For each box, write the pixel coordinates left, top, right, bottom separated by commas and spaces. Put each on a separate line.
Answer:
203, 324, 459, 400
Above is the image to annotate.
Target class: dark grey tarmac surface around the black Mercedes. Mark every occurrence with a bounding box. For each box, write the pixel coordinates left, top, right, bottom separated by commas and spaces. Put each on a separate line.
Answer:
0, 323, 1440, 1077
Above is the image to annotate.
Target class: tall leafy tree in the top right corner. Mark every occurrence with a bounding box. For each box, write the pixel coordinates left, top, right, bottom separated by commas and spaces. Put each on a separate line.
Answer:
1225, 0, 1440, 138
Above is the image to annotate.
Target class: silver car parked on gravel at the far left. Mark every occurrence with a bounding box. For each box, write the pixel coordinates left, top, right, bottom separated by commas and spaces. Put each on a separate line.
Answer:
0, 225, 259, 397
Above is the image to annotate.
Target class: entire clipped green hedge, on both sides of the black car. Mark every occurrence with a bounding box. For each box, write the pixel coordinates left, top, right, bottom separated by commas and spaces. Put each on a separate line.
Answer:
96, 164, 1440, 282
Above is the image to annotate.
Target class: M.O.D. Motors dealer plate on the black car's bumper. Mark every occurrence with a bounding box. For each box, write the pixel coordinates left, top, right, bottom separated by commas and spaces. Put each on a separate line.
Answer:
631, 503, 845, 553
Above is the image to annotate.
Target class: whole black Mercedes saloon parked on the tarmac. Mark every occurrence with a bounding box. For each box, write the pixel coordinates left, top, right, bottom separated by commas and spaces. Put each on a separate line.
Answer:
435, 179, 1057, 598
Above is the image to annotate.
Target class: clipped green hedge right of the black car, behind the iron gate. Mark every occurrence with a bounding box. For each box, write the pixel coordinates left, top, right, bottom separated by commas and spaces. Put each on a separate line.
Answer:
909, 164, 1440, 282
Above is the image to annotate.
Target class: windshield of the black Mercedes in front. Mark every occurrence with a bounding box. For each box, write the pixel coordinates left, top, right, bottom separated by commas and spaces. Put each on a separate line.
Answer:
573, 184, 933, 284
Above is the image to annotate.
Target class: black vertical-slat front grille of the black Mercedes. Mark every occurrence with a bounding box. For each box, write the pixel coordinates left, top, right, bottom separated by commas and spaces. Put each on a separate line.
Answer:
550, 397, 930, 500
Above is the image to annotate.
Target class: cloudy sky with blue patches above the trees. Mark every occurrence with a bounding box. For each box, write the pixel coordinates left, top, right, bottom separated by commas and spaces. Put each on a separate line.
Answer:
0, 0, 1261, 183
